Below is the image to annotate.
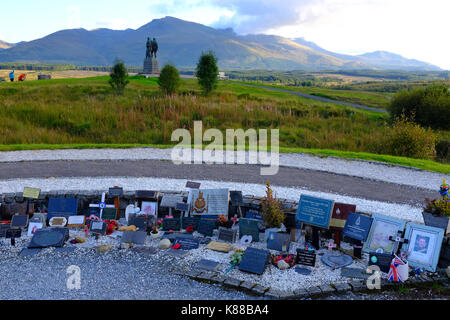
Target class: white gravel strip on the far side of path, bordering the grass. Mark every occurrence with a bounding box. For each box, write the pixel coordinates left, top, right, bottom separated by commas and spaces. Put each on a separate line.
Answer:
0, 148, 442, 190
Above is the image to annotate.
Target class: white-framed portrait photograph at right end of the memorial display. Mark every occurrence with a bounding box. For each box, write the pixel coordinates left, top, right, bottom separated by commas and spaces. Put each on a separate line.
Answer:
404, 223, 444, 272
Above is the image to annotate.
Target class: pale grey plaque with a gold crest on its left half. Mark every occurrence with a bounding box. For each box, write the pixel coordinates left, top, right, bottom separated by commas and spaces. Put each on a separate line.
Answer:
189, 189, 229, 216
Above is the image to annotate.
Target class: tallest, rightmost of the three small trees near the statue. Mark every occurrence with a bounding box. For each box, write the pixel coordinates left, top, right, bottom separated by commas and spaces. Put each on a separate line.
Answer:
195, 51, 219, 94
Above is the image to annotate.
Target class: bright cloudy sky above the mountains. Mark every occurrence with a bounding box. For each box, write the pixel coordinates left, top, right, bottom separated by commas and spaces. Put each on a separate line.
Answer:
0, 0, 450, 70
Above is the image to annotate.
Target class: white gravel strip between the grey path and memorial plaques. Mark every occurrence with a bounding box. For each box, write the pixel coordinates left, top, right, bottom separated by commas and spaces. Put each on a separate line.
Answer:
0, 177, 423, 223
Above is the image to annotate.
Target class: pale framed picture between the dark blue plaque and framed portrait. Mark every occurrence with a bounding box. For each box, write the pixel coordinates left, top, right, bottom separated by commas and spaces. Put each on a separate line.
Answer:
363, 213, 406, 253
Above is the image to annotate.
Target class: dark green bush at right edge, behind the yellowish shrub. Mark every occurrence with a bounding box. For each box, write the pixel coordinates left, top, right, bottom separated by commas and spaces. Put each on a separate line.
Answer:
388, 84, 450, 129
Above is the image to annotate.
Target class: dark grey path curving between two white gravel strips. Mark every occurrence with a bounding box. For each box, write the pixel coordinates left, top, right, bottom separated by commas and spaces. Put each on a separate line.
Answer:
0, 160, 435, 205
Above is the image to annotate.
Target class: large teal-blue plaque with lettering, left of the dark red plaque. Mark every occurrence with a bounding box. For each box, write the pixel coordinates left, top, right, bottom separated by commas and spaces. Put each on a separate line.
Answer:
296, 194, 334, 229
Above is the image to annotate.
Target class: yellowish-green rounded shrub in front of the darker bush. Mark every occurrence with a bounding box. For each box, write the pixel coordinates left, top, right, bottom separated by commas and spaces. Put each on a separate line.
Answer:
383, 115, 437, 159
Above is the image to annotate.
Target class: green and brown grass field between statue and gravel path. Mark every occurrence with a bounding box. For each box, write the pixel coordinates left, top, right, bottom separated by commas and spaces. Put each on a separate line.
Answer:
0, 76, 449, 172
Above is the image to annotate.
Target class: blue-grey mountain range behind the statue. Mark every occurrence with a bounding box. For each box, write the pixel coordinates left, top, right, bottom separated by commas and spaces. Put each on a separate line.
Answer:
0, 17, 441, 71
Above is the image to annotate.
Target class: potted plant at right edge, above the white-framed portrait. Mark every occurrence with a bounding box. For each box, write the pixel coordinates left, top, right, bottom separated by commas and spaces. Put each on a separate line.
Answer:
422, 179, 450, 231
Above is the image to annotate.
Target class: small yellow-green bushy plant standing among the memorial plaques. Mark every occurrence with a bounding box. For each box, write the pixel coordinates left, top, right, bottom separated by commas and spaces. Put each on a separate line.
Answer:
261, 181, 286, 241
